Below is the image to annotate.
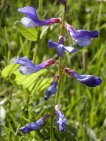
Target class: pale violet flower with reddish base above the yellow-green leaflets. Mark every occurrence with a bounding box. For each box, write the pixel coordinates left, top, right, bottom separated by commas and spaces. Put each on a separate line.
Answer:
14, 57, 56, 75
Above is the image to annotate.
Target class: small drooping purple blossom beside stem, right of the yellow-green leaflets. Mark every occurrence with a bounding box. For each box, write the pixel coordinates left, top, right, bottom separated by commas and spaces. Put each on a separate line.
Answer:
44, 76, 59, 100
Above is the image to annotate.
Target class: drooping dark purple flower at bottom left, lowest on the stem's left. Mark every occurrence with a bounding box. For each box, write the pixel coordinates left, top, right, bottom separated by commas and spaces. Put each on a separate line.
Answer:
20, 115, 49, 134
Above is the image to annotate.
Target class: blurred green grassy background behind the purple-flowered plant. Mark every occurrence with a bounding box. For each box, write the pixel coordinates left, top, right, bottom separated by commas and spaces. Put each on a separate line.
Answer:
0, 0, 106, 141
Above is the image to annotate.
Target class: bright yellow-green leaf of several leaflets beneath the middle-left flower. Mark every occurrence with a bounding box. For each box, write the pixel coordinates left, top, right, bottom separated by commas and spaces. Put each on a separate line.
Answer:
1, 64, 53, 92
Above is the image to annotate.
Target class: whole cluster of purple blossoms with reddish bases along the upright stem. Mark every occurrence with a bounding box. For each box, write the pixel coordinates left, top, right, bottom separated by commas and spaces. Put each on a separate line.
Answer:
14, 0, 102, 134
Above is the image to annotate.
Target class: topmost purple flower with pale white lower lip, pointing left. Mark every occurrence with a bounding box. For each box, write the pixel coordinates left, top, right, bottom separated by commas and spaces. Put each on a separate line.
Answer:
18, 6, 61, 28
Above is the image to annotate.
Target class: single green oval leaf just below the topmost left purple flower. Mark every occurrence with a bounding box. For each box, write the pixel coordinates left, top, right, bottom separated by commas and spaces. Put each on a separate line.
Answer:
16, 22, 38, 41
